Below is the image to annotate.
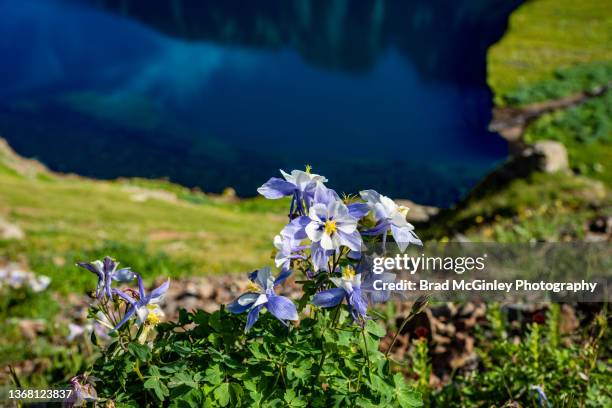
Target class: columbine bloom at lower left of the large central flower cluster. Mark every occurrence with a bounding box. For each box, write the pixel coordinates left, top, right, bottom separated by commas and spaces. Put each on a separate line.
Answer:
227, 267, 298, 331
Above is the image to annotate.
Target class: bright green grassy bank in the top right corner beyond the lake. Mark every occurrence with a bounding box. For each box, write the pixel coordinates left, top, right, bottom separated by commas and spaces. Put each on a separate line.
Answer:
487, 0, 612, 104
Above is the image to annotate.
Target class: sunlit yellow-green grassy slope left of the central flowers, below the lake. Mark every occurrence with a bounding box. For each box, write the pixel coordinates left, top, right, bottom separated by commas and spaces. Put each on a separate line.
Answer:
0, 139, 286, 291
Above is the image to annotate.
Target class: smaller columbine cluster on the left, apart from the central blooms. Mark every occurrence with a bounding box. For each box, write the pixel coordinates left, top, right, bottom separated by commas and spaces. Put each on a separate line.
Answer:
78, 257, 170, 341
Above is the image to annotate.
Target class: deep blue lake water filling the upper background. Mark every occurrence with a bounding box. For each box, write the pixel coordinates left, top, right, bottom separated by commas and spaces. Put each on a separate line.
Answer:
0, 0, 519, 206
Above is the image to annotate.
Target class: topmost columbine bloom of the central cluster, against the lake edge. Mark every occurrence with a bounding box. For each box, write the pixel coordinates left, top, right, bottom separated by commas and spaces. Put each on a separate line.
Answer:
257, 170, 327, 217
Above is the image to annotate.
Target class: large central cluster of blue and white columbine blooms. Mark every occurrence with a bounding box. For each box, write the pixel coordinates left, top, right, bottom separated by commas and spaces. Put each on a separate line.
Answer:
228, 167, 421, 330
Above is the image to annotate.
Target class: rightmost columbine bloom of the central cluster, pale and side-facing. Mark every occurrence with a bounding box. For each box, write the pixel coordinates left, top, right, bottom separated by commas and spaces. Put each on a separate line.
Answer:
359, 190, 422, 252
